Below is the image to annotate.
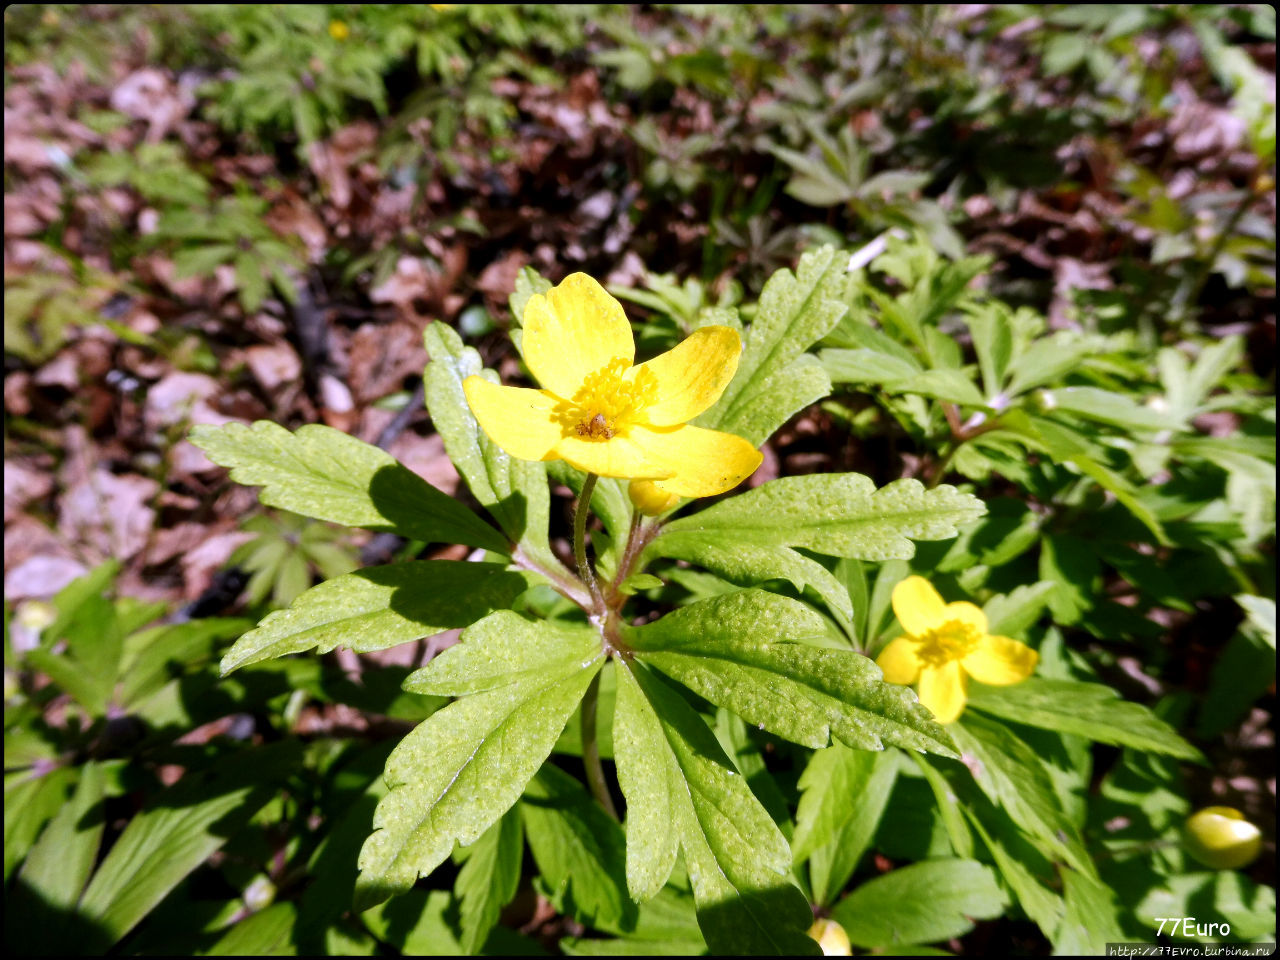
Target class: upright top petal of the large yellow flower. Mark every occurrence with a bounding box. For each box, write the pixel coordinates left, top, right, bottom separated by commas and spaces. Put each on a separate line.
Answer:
522, 274, 636, 399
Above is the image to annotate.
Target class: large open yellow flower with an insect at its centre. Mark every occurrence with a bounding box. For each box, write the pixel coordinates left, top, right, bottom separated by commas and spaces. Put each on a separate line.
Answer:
462, 274, 760, 497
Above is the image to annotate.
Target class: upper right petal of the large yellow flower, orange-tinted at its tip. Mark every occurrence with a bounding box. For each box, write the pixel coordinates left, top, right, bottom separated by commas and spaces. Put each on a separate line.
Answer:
627, 326, 742, 426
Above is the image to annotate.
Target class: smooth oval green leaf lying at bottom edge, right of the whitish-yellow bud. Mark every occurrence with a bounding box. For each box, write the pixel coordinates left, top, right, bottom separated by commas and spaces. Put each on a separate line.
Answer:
831, 859, 1007, 947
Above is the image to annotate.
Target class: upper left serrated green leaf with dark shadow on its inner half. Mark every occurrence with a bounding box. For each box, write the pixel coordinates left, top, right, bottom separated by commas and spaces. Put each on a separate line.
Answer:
191, 420, 509, 553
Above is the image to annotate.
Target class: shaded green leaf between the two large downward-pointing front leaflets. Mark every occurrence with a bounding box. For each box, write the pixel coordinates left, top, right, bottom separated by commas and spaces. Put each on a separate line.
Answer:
520, 764, 637, 934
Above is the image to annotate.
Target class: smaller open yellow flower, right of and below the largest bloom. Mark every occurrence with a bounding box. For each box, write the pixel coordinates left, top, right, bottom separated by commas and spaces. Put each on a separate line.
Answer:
876, 576, 1039, 723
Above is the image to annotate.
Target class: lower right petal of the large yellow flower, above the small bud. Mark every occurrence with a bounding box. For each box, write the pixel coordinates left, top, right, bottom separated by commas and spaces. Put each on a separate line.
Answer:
630, 424, 764, 497
